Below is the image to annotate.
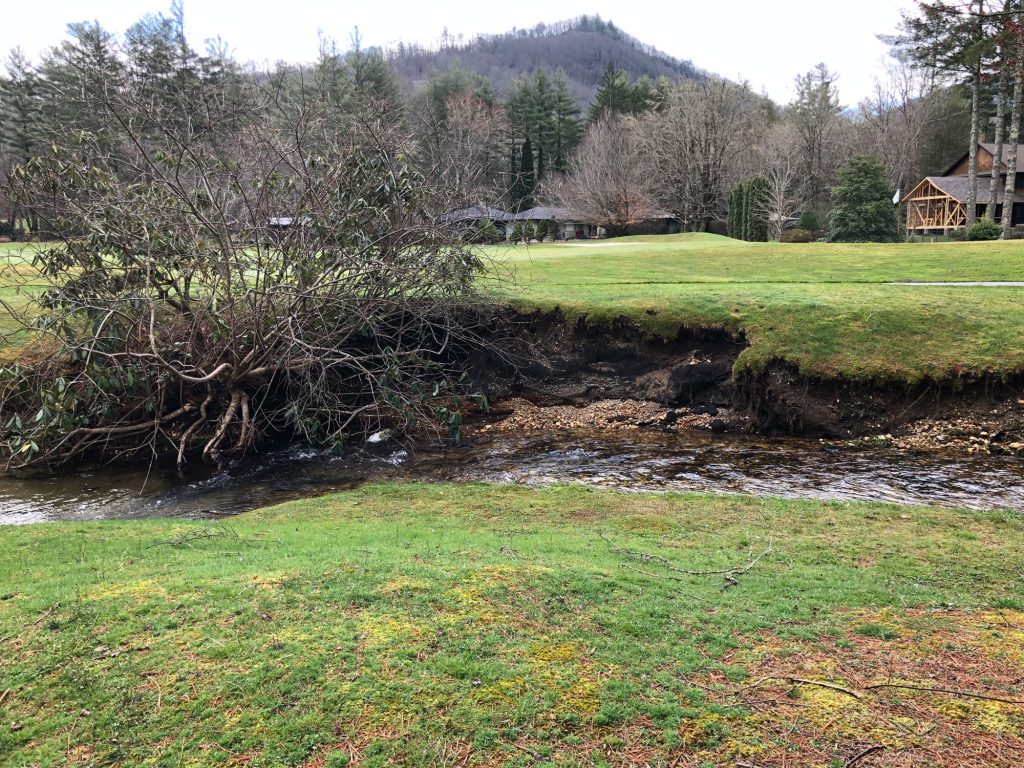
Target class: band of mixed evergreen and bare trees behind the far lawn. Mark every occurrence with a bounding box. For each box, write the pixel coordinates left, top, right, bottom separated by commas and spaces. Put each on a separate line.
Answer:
0, 0, 1022, 237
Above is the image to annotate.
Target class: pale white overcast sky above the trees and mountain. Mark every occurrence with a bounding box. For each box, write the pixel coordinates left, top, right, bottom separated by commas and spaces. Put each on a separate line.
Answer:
0, 0, 912, 105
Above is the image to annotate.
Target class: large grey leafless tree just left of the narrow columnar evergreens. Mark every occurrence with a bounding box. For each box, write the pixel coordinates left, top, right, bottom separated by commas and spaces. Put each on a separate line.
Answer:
643, 78, 764, 231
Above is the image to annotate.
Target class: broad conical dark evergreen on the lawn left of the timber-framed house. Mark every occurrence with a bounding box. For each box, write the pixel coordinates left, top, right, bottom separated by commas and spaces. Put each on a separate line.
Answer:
828, 157, 900, 243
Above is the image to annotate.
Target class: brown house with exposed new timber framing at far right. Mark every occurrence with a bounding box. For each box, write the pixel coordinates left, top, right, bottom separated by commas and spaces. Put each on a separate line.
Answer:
902, 142, 1024, 234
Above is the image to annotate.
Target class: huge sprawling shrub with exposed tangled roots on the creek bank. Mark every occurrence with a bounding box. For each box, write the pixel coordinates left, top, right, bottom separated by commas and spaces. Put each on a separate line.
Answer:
0, 55, 495, 466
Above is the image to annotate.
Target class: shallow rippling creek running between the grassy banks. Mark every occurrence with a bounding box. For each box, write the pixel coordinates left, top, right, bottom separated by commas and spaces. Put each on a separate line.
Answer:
0, 430, 1024, 524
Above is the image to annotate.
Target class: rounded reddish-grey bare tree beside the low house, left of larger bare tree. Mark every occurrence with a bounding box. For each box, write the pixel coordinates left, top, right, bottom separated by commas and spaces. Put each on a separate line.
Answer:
545, 116, 656, 237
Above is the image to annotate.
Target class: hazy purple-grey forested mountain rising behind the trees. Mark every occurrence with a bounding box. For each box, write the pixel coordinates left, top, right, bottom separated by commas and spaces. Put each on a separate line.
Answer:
389, 16, 702, 104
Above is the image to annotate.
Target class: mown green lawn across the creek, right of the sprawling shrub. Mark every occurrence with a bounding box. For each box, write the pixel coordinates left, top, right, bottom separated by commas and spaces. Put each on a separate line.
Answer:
495, 234, 1024, 381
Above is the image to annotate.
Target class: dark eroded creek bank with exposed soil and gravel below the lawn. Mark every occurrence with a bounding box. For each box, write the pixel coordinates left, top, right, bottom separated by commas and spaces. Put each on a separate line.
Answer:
473, 312, 1024, 455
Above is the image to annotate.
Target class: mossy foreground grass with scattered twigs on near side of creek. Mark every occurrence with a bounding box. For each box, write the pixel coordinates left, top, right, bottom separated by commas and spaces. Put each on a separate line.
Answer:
0, 484, 1024, 768
